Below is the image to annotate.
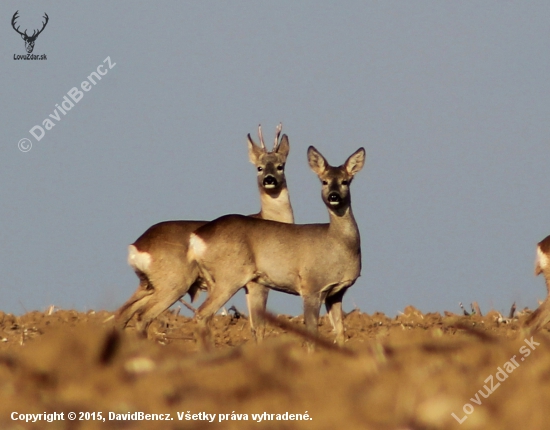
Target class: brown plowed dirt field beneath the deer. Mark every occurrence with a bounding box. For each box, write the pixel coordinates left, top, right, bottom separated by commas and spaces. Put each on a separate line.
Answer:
0, 307, 550, 430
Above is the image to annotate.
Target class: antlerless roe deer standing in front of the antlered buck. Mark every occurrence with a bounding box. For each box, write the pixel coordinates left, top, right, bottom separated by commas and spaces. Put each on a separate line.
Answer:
189, 146, 365, 347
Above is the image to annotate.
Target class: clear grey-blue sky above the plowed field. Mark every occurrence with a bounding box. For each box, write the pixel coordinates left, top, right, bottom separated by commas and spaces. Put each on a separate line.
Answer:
0, 1, 550, 315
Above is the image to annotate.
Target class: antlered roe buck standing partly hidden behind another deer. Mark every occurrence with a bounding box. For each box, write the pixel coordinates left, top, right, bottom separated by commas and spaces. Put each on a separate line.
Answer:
115, 124, 294, 338
